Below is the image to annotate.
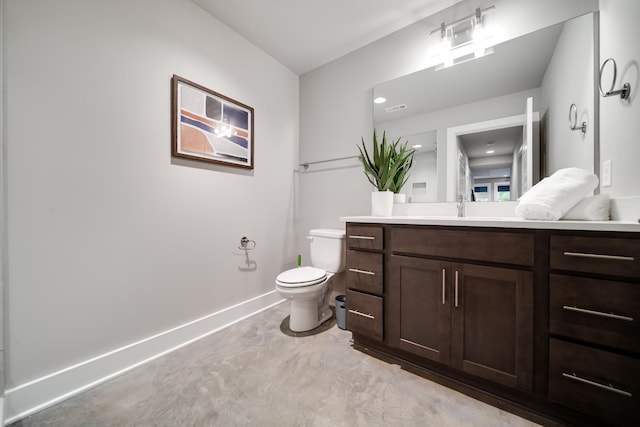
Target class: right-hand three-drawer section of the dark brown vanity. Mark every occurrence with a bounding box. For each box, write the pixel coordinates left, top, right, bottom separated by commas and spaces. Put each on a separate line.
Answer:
549, 234, 640, 425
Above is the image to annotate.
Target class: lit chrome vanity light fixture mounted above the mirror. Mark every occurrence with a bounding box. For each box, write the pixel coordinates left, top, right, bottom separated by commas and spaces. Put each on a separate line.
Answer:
429, 6, 495, 70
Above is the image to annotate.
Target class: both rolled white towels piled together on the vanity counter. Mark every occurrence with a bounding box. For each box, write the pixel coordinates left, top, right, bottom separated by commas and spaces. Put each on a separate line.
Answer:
516, 168, 610, 221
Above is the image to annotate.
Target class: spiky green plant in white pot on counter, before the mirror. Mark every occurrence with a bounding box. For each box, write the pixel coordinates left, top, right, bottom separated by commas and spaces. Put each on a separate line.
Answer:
358, 129, 414, 216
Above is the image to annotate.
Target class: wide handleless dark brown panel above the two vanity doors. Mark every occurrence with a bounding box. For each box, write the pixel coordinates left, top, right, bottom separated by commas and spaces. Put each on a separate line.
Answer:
390, 227, 534, 265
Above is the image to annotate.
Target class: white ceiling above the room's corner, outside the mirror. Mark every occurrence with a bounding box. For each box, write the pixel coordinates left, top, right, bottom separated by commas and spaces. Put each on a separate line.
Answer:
192, 0, 461, 75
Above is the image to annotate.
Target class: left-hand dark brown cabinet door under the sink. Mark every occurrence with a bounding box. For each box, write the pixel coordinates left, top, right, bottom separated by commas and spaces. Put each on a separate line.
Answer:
385, 255, 452, 364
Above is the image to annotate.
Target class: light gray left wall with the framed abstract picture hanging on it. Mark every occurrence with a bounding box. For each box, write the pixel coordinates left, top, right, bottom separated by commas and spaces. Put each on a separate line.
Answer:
0, 0, 299, 414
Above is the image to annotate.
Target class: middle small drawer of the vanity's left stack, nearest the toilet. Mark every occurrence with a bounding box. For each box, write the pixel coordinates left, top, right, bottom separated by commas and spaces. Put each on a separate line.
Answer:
347, 249, 384, 294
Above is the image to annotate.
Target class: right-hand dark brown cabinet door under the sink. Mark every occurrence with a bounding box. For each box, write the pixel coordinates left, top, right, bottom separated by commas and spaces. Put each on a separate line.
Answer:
451, 264, 533, 391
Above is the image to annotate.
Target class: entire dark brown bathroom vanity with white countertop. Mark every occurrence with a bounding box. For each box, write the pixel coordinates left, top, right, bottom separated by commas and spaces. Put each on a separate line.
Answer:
343, 217, 640, 425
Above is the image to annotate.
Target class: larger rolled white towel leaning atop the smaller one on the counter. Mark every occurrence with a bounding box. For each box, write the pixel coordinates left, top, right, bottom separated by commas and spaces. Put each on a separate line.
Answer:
516, 168, 598, 221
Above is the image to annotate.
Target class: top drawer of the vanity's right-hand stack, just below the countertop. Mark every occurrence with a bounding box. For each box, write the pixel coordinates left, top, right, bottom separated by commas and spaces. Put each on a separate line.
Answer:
549, 236, 640, 277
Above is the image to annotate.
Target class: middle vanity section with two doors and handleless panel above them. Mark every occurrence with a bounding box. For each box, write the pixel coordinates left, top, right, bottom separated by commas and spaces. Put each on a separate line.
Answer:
385, 227, 533, 391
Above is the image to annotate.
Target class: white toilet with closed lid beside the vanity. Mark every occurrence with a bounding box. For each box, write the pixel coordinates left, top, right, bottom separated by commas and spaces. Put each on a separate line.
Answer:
276, 228, 345, 332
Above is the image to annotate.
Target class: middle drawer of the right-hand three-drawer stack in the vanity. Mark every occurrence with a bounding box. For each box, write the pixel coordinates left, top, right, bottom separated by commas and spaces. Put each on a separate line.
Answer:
549, 274, 640, 352
